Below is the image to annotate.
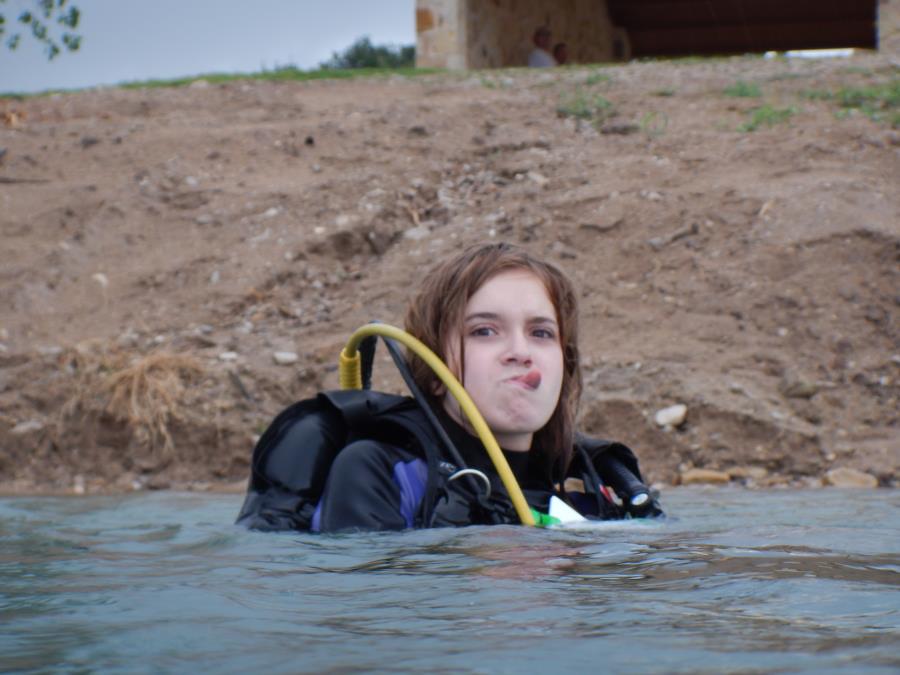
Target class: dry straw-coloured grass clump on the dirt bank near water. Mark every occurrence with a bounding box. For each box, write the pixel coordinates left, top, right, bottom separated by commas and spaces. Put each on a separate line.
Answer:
63, 352, 204, 457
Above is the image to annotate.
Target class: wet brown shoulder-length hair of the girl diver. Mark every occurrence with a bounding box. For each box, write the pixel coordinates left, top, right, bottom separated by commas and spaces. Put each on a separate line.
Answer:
406, 242, 582, 480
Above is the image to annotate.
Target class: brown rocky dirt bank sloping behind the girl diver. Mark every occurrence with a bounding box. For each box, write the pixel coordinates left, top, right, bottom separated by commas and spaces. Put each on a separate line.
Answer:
0, 46, 900, 493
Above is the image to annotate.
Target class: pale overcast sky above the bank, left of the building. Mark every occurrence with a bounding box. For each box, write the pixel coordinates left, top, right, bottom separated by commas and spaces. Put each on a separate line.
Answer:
0, 0, 415, 92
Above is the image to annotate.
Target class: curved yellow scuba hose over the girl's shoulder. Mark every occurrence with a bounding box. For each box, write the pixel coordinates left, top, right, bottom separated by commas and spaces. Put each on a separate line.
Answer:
338, 323, 535, 526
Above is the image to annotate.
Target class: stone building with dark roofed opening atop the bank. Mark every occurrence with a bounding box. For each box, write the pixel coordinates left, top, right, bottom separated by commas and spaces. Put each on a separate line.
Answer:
416, 0, 884, 69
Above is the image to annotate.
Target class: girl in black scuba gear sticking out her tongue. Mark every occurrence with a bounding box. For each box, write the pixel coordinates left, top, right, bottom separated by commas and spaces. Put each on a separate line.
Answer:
238, 243, 662, 532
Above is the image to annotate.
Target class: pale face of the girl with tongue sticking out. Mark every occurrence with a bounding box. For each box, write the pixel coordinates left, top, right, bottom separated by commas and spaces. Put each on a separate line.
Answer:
444, 269, 563, 451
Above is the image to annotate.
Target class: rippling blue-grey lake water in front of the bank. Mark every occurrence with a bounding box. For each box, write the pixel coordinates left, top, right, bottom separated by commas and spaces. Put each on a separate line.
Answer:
0, 488, 900, 675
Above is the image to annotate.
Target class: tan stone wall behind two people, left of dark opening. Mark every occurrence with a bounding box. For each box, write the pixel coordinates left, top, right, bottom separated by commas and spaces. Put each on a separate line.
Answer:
416, 0, 628, 68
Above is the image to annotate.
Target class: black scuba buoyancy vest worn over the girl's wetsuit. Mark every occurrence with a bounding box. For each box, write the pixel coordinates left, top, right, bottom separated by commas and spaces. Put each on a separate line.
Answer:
237, 390, 662, 530
